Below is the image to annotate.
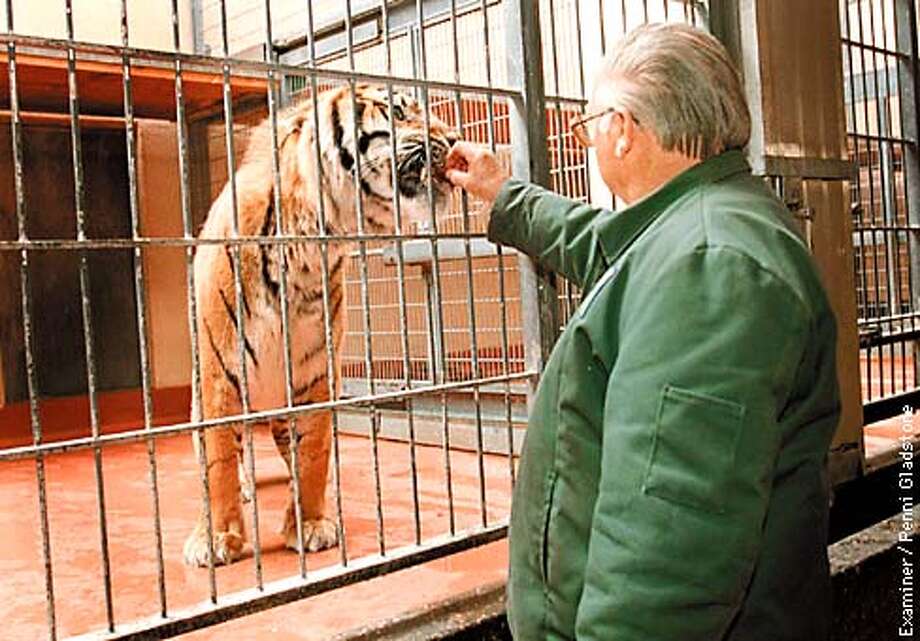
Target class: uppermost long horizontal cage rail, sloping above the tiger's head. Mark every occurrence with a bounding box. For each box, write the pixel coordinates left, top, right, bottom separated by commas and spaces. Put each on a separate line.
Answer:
0, 33, 521, 99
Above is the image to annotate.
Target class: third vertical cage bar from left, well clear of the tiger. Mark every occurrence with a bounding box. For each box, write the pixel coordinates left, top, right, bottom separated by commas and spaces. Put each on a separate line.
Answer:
121, 0, 166, 617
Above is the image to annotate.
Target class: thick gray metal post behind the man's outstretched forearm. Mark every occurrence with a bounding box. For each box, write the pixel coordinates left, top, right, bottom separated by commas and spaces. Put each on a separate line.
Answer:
505, 0, 559, 392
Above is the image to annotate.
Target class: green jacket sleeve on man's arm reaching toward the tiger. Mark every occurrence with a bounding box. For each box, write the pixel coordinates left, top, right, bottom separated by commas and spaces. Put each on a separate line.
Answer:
488, 178, 605, 287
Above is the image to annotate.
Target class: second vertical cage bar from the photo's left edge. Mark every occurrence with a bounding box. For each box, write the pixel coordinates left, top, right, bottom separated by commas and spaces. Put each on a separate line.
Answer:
64, 0, 115, 632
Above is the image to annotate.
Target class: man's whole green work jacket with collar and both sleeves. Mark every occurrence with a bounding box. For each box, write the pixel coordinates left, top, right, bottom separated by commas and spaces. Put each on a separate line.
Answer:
489, 151, 840, 641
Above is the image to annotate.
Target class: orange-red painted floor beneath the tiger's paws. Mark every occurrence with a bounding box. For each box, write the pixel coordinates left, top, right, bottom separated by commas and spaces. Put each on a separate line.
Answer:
0, 433, 510, 640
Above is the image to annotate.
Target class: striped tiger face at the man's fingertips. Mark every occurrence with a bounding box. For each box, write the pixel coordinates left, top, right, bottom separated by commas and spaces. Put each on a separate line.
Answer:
298, 84, 459, 233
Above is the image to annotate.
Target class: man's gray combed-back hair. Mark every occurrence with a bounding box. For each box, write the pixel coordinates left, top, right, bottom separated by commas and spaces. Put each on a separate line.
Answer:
601, 24, 751, 159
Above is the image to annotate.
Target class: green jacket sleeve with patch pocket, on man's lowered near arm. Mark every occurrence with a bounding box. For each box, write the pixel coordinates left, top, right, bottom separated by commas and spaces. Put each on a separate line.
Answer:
576, 248, 811, 641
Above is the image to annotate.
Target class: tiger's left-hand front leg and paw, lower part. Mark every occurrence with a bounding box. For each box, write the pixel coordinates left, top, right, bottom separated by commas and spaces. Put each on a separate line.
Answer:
184, 380, 246, 567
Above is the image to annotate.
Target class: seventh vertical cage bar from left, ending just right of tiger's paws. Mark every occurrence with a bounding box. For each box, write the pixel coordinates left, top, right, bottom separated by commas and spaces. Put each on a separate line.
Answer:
308, 0, 348, 576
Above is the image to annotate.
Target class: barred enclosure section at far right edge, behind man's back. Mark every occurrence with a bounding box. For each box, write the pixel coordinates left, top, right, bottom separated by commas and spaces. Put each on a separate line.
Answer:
840, 0, 918, 413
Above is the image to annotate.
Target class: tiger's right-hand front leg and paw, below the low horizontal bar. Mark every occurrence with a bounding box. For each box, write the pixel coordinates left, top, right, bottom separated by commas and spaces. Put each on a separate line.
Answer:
276, 411, 338, 552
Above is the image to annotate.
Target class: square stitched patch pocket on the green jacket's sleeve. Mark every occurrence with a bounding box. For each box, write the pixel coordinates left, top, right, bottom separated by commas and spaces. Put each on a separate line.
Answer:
642, 385, 745, 513
